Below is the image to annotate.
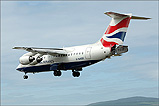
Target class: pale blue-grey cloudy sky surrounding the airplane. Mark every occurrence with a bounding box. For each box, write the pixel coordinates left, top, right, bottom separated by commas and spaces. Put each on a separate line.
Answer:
1, 1, 158, 105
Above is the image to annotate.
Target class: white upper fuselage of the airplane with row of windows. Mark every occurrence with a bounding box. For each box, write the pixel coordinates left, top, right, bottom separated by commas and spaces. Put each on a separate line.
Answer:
17, 42, 110, 71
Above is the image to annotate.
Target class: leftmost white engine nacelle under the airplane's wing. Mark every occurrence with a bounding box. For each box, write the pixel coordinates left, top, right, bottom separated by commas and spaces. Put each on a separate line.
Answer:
19, 56, 35, 65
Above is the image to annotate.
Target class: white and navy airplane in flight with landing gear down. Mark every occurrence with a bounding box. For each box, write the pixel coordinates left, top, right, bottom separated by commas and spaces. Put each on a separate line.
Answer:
13, 12, 151, 79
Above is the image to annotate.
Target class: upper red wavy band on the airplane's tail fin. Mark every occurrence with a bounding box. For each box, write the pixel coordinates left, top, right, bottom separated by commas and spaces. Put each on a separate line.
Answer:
105, 17, 131, 34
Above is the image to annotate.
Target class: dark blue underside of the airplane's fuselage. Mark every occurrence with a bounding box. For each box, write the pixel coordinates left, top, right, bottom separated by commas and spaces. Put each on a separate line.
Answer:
17, 60, 100, 72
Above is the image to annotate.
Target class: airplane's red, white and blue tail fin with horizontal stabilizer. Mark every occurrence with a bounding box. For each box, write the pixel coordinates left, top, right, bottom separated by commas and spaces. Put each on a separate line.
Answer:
100, 12, 150, 47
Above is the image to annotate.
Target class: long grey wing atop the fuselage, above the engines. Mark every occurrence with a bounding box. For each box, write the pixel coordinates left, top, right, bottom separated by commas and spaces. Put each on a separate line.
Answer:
13, 47, 67, 55
